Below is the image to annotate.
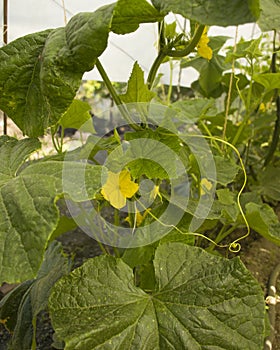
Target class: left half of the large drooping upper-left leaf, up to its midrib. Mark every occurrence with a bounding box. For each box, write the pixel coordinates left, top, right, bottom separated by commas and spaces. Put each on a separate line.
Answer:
0, 30, 52, 136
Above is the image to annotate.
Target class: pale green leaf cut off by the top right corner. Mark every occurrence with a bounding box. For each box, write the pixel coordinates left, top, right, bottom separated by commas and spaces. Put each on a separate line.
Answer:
258, 0, 280, 32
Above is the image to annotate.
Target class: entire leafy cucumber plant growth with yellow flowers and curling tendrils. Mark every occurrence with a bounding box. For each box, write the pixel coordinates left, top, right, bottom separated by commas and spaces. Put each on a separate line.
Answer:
0, 0, 280, 350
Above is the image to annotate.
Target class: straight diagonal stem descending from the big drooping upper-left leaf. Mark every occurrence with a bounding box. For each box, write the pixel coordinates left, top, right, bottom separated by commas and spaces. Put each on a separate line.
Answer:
95, 59, 141, 130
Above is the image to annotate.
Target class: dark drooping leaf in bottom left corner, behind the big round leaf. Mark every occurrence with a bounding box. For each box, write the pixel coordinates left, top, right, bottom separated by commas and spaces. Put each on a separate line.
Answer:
0, 242, 70, 350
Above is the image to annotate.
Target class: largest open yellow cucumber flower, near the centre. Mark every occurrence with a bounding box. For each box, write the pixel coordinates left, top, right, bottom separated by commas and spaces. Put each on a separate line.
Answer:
101, 170, 139, 209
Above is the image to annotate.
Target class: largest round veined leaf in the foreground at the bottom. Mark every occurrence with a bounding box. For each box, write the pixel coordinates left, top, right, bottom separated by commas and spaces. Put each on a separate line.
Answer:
49, 243, 265, 350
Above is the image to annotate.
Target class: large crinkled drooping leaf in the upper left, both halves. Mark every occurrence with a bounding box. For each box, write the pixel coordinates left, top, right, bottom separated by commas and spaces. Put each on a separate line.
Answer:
0, 4, 114, 137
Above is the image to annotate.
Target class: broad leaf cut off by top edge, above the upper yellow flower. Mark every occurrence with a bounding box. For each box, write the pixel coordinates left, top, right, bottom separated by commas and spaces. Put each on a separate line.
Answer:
152, 0, 260, 26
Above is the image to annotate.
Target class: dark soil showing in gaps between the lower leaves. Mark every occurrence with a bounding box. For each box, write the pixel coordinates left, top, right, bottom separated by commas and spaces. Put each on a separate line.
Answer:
0, 229, 280, 350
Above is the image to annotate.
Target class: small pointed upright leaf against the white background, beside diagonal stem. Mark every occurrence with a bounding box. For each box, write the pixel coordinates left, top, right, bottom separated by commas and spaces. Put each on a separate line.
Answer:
120, 62, 155, 103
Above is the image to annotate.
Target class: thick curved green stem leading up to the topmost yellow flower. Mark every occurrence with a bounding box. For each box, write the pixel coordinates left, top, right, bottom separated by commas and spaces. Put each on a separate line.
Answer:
147, 24, 205, 89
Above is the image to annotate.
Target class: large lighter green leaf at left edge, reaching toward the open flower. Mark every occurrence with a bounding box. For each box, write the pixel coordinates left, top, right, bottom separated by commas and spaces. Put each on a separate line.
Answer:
0, 139, 102, 283
